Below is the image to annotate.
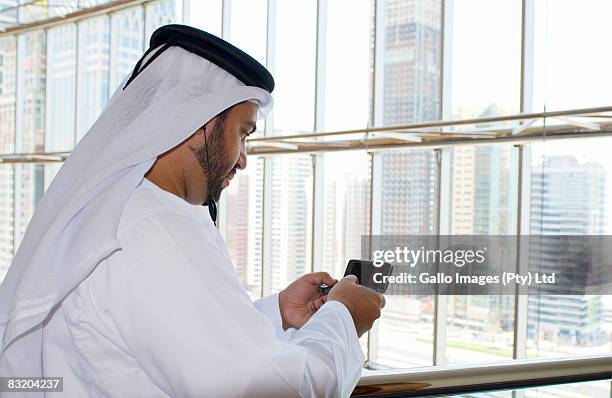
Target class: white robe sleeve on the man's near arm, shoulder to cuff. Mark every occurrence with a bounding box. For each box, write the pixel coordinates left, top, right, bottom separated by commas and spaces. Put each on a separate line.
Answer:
108, 214, 364, 398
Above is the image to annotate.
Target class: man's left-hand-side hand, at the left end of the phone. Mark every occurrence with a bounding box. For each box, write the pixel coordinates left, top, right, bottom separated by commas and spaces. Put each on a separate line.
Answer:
278, 272, 338, 329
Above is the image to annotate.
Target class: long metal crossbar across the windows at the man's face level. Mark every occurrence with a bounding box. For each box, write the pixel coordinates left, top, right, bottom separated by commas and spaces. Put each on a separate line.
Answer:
0, 106, 612, 163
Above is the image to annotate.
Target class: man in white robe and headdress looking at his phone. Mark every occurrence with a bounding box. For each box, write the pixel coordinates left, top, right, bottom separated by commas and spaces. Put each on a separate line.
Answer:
0, 25, 384, 397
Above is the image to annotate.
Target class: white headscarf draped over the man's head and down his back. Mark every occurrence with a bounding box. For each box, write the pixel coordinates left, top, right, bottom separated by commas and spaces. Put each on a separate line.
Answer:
0, 25, 273, 376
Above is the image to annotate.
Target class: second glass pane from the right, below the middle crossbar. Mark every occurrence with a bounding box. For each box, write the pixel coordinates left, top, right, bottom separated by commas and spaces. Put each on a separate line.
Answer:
445, 145, 518, 363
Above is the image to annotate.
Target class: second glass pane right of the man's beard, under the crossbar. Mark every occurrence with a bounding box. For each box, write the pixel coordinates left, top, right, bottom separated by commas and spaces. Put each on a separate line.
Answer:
264, 156, 312, 292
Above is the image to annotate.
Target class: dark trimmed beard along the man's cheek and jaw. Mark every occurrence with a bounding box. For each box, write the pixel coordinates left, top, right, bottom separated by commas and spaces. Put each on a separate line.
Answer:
189, 121, 232, 202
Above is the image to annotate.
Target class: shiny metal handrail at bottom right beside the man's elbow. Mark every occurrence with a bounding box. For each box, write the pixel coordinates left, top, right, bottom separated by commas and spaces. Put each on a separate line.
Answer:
351, 354, 612, 398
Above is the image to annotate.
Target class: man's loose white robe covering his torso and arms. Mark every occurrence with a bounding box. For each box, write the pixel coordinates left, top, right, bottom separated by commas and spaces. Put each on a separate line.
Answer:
42, 178, 364, 398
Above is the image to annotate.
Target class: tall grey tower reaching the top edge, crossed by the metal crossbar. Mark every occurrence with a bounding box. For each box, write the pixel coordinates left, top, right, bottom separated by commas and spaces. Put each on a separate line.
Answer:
381, 0, 441, 234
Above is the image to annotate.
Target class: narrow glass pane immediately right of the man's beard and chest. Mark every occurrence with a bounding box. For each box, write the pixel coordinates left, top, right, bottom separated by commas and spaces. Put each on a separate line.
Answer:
222, 157, 264, 299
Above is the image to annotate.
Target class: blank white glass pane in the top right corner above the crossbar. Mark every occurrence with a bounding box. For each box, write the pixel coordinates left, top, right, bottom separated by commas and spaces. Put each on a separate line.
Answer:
533, 0, 612, 112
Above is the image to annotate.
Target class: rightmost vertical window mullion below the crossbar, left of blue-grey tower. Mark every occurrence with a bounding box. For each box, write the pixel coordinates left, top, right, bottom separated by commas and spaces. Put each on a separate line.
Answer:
512, 145, 531, 359
